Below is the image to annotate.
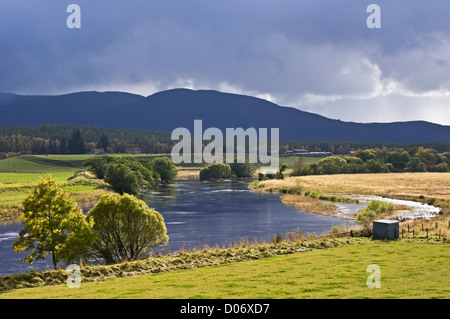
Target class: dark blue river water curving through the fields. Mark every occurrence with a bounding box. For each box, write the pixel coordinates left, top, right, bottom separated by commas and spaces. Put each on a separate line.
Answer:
0, 180, 354, 276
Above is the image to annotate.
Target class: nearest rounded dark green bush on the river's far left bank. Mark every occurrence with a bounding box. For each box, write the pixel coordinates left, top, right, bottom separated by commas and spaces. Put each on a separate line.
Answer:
105, 163, 144, 195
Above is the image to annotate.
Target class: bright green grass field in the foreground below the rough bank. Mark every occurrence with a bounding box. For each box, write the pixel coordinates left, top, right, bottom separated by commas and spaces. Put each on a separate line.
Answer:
0, 241, 450, 299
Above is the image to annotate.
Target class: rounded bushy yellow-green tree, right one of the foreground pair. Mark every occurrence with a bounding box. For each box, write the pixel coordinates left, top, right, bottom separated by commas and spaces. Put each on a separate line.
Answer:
87, 194, 169, 264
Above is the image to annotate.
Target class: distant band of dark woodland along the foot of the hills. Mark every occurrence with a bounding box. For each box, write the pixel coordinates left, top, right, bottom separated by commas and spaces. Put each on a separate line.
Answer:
0, 125, 450, 158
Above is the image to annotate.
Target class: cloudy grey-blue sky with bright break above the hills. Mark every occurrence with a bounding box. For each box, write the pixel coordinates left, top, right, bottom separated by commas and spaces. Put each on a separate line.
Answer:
0, 0, 450, 125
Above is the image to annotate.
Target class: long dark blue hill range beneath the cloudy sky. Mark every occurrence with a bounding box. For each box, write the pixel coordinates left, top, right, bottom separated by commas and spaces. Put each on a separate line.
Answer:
0, 89, 450, 143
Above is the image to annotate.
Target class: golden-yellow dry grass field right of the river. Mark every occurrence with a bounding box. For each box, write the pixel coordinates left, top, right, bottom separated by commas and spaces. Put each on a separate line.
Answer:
253, 173, 450, 214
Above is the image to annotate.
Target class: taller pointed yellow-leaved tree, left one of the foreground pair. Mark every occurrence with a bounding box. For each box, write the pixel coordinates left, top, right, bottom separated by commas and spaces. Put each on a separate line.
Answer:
13, 177, 92, 270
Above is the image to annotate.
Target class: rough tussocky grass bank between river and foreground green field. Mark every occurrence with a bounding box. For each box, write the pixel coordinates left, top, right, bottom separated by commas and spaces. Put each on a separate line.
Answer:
0, 236, 369, 292
